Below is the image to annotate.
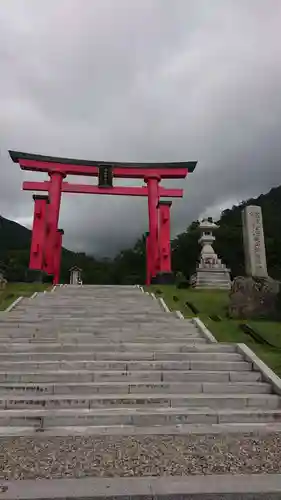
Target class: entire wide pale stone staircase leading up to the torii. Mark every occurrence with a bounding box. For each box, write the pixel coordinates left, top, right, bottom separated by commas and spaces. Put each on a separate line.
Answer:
0, 286, 281, 434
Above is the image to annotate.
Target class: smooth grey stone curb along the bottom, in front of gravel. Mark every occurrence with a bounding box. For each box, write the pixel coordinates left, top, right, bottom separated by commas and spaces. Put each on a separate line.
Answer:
0, 474, 281, 500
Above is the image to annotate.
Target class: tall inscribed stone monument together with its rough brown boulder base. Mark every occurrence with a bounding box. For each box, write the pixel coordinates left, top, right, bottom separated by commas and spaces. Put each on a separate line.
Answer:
229, 205, 280, 319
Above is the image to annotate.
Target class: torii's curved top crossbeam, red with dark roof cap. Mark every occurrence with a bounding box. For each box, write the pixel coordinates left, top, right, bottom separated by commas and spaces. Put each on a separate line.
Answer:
9, 151, 197, 179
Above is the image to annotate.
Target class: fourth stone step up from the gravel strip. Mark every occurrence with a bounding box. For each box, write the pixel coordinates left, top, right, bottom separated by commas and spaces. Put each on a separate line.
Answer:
0, 381, 272, 397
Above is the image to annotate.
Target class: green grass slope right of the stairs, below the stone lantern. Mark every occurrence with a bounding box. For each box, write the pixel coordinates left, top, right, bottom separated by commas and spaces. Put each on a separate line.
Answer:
148, 285, 281, 377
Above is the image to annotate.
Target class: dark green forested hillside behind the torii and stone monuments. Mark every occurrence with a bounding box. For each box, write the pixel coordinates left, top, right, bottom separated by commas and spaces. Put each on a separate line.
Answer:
0, 186, 281, 284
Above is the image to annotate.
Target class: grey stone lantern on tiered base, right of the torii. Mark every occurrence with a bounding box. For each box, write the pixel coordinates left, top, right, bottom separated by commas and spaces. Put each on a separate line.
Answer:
190, 217, 231, 290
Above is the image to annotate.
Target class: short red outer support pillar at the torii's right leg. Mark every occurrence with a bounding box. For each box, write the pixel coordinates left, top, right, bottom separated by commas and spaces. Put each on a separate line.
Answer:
157, 201, 174, 284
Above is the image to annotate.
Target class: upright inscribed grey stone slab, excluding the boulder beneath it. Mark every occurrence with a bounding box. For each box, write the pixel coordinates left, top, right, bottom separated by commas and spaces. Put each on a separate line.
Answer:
242, 205, 268, 278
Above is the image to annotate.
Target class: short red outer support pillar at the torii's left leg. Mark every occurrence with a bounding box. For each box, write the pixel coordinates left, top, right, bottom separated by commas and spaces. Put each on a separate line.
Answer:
29, 195, 49, 271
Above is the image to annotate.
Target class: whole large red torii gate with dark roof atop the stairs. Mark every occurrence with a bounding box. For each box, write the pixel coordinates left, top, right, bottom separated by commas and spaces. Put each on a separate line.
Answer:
9, 151, 197, 283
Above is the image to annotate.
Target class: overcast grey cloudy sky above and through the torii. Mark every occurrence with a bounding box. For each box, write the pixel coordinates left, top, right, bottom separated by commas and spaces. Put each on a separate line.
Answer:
0, 0, 281, 255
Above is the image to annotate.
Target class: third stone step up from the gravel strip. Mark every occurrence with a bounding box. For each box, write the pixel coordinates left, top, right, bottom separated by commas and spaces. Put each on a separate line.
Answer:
0, 392, 276, 412
